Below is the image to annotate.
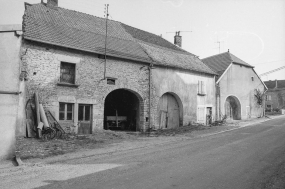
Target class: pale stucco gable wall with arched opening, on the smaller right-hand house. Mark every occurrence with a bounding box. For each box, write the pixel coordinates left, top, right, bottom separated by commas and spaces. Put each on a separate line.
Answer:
219, 64, 265, 119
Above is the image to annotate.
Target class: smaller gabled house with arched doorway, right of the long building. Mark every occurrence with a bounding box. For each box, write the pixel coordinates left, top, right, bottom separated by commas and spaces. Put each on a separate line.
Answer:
202, 52, 266, 120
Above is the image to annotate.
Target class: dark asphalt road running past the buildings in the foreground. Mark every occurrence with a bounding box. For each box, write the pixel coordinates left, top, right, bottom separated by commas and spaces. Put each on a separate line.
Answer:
35, 117, 285, 189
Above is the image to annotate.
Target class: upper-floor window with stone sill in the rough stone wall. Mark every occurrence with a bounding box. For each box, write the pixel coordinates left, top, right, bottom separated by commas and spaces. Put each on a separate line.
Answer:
60, 62, 75, 84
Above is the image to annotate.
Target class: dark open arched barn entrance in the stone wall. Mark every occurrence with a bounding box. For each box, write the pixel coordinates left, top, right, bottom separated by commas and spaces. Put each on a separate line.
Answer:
104, 89, 140, 131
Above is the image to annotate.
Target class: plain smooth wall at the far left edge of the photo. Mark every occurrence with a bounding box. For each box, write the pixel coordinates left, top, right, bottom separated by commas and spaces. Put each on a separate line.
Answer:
0, 31, 21, 160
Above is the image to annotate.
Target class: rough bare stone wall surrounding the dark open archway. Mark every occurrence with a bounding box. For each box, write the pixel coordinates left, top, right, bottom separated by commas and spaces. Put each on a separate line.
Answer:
22, 41, 149, 132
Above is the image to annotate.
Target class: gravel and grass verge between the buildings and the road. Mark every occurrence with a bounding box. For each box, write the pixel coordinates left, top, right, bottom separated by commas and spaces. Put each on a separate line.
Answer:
14, 118, 272, 160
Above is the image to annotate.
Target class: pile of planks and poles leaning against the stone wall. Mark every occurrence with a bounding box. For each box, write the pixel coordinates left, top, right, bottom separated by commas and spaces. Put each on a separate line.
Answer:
26, 92, 65, 139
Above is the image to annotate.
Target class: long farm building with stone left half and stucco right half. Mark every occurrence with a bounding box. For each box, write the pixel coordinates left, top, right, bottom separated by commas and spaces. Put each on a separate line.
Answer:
21, 0, 216, 134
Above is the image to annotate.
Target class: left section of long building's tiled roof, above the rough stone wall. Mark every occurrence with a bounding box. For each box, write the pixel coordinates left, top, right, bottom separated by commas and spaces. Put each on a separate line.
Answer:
23, 4, 150, 62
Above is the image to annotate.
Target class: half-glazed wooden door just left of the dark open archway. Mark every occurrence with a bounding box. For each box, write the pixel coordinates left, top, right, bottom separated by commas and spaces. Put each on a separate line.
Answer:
78, 104, 92, 134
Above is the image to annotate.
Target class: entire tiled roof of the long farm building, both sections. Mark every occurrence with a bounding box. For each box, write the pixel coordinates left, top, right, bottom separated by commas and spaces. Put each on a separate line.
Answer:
23, 3, 214, 74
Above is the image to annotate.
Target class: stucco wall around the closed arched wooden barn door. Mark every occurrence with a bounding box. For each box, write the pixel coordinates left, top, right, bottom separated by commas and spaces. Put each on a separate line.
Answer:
152, 67, 215, 128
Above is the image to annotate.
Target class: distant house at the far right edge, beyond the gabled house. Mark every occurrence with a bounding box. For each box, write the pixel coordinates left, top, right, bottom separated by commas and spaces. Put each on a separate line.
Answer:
264, 80, 285, 112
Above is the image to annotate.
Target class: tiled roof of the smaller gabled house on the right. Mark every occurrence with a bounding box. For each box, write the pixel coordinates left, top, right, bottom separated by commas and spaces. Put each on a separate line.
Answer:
202, 52, 253, 75
